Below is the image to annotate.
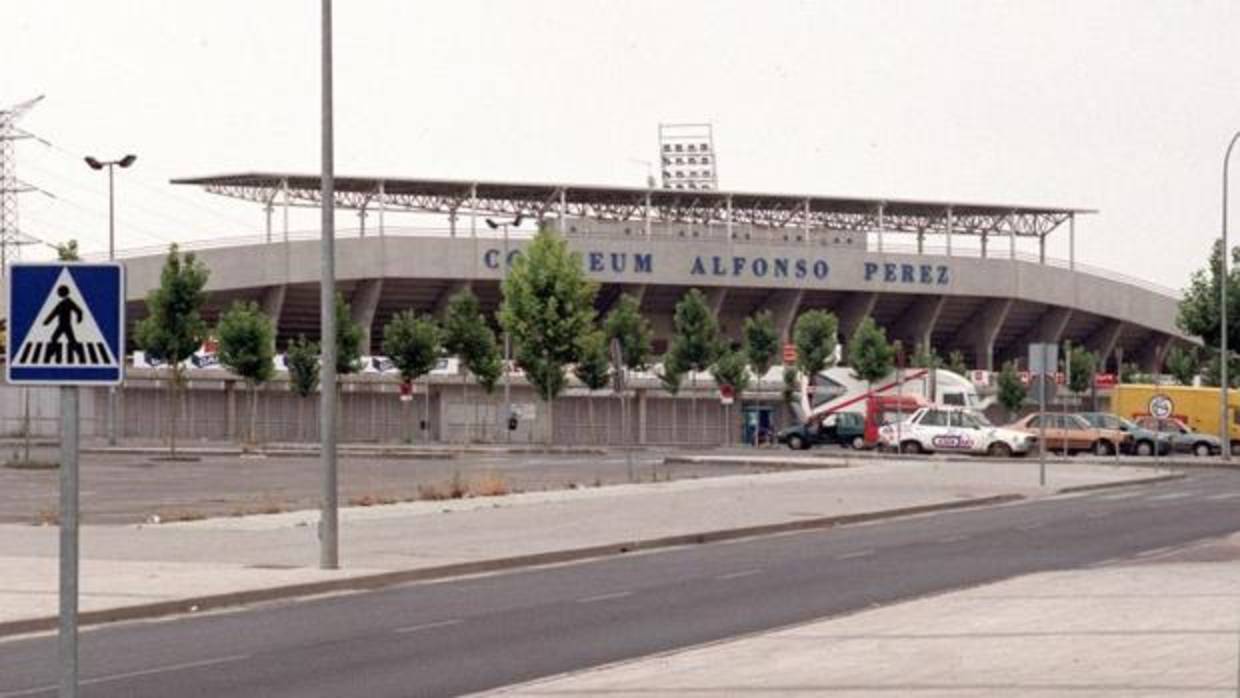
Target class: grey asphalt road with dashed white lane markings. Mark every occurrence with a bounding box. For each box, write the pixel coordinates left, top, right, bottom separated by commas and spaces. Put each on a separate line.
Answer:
0, 472, 1240, 698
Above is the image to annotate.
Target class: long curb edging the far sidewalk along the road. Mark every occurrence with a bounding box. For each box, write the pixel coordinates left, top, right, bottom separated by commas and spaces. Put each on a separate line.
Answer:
0, 495, 1024, 637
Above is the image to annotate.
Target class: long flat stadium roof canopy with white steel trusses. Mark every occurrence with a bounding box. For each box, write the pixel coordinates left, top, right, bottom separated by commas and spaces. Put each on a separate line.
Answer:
172, 172, 1096, 238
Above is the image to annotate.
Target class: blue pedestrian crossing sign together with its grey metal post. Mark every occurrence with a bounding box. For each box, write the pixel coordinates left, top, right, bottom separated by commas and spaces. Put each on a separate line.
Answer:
5, 263, 125, 698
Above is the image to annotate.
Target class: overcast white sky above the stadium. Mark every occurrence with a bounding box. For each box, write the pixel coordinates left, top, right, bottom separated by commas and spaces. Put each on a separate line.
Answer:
0, 0, 1240, 288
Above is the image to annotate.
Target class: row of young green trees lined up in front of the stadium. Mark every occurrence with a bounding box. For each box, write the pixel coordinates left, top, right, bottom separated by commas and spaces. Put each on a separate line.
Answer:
135, 229, 942, 453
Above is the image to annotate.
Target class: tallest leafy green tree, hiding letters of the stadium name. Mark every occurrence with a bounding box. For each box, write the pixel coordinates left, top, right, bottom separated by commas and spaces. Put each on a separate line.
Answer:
500, 226, 599, 443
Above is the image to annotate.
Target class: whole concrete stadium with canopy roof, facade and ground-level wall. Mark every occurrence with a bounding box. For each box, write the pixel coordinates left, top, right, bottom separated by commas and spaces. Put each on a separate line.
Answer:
0, 172, 1189, 443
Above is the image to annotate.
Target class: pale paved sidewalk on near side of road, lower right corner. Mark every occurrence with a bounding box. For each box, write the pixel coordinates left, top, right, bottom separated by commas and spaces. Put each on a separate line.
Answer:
491, 538, 1240, 698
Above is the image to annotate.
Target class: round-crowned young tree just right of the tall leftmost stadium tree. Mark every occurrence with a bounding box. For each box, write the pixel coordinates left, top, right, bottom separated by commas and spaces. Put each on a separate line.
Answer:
216, 300, 275, 444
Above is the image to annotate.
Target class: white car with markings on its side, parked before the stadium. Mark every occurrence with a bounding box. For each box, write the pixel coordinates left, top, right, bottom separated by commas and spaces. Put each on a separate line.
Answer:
878, 407, 1038, 457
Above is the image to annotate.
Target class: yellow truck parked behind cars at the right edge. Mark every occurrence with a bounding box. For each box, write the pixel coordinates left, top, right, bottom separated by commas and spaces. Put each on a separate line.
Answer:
1111, 383, 1240, 454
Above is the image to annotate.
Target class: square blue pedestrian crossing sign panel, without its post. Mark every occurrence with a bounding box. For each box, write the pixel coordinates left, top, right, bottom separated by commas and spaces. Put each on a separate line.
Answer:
5, 262, 125, 386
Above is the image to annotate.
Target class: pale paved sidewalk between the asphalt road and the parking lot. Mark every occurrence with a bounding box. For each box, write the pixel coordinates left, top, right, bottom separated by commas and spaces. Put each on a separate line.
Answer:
0, 461, 1151, 626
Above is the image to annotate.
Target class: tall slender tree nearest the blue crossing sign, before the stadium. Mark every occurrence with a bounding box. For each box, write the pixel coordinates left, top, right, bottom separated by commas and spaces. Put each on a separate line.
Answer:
134, 243, 211, 457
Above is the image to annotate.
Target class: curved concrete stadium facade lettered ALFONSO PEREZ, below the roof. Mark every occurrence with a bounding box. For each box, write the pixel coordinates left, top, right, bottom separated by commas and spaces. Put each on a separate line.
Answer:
101, 222, 1185, 369
